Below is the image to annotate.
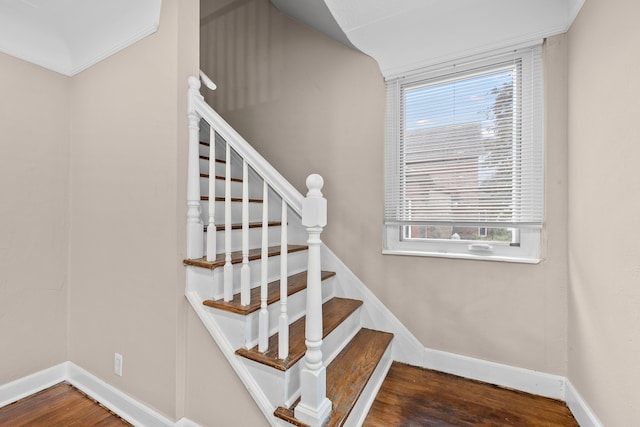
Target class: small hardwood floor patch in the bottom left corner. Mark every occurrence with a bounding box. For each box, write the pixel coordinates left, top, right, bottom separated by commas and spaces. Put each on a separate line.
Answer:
0, 383, 130, 427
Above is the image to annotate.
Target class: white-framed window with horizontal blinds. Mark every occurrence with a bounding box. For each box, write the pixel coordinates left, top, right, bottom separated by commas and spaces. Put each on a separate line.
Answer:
383, 46, 544, 263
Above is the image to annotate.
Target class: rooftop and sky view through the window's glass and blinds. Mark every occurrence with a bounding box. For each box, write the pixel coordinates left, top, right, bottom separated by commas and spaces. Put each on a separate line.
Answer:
403, 62, 519, 243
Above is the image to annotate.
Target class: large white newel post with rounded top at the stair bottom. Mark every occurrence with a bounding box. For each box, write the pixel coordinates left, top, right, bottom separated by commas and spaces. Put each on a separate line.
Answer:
295, 174, 331, 427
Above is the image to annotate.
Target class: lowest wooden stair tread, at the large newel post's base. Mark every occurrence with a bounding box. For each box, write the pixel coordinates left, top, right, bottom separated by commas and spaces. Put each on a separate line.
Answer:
274, 328, 393, 427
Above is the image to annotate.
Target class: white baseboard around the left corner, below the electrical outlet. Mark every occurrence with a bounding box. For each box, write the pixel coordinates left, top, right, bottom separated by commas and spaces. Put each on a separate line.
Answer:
0, 362, 199, 427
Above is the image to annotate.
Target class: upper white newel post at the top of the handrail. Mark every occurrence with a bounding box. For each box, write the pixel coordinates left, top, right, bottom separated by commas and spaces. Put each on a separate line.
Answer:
187, 76, 204, 259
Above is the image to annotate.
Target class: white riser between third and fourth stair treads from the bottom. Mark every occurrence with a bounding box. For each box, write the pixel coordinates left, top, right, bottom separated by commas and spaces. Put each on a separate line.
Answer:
188, 251, 307, 300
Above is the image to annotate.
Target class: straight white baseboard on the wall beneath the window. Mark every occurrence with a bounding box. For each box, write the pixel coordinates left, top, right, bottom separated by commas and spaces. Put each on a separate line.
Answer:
422, 348, 565, 400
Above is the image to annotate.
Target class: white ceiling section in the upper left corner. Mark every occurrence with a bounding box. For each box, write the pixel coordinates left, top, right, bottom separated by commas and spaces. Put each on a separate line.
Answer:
0, 0, 161, 76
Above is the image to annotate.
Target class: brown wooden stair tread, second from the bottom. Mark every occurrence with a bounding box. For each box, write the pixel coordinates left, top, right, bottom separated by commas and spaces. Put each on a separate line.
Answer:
236, 297, 362, 371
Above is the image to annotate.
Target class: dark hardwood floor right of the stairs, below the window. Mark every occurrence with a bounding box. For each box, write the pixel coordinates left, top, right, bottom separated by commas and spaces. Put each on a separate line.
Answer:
364, 362, 578, 427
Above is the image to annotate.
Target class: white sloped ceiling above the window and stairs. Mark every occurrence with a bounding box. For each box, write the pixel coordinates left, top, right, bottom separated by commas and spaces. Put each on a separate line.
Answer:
271, 0, 585, 77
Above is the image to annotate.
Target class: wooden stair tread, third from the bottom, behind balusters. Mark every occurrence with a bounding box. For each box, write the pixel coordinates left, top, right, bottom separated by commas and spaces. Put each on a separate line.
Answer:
202, 271, 336, 315
